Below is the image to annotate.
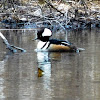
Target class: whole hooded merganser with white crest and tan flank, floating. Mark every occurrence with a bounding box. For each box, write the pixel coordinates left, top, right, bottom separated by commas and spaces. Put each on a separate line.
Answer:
34, 28, 84, 52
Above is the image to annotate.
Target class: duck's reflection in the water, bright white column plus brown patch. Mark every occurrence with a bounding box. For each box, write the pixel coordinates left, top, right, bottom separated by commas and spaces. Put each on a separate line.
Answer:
37, 51, 61, 77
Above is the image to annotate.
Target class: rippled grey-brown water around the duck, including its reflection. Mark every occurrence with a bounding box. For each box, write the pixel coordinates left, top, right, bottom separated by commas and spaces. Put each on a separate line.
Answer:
0, 29, 100, 100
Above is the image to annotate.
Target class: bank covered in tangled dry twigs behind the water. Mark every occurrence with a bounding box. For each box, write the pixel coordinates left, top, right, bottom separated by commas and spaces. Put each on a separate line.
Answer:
0, 0, 100, 30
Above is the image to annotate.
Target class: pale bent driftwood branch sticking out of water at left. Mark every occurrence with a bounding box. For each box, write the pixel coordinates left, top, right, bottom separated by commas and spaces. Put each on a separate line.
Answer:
0, 32, 26, 53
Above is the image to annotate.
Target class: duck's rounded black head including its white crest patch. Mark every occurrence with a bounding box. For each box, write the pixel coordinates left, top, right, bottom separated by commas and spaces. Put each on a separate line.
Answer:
37, 28, 52, 42
